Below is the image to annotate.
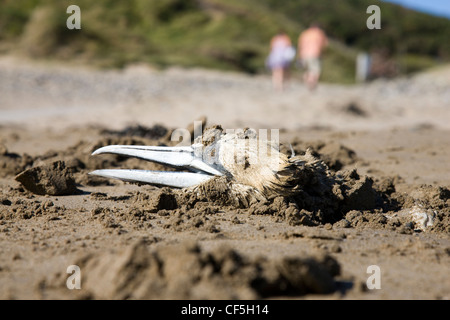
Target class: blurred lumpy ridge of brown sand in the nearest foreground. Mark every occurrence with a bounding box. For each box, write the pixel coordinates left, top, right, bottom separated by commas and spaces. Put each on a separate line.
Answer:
68, 241, 340, 299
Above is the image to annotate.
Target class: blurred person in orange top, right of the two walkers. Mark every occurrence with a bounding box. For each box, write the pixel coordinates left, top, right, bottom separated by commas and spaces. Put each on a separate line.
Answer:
298, 23, 328, 90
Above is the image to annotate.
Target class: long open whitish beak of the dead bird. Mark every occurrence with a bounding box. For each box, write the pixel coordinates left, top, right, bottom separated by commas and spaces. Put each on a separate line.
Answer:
90, 145, 223, 188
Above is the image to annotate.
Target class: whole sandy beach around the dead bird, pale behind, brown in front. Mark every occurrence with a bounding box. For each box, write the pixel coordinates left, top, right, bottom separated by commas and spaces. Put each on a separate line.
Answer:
0, 57, 450, 299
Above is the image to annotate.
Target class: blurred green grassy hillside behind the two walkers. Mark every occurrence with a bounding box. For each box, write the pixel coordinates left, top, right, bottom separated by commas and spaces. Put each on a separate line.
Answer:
0, 0, 450, 83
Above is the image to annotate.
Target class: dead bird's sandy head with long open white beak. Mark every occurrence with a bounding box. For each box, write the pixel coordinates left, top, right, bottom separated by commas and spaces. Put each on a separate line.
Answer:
91, 126, 328, 203
